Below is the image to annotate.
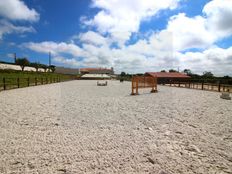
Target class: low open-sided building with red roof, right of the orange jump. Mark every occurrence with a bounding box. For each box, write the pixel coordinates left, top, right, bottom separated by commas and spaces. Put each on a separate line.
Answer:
145, 72, 191, 84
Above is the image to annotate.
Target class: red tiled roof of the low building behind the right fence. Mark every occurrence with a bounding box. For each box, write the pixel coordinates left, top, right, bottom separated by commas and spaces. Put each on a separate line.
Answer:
145, 72, 191, 78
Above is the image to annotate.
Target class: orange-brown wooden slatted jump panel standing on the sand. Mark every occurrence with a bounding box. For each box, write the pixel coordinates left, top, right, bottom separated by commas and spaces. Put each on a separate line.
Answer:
131, 76, 157, 95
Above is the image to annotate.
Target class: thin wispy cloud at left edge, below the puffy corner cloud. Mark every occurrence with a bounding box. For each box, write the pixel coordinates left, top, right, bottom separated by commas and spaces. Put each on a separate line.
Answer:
0, 20, 36, 40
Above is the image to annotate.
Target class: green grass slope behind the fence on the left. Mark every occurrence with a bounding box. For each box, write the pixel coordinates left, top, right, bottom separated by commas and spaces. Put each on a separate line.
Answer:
0, 70, 75, 90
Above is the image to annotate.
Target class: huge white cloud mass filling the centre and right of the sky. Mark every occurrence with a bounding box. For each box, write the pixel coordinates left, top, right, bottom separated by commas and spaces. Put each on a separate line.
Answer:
24, 0, 232, 75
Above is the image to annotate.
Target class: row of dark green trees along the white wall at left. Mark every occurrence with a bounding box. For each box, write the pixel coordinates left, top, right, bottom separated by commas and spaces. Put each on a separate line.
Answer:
15, 58, 56, 72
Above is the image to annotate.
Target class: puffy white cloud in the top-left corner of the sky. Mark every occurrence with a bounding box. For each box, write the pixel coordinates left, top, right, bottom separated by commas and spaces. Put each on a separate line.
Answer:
0, 0, 39, 21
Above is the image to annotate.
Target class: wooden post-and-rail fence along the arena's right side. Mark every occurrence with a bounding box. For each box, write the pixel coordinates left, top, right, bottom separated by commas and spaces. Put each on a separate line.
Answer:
163, 82, 232, 92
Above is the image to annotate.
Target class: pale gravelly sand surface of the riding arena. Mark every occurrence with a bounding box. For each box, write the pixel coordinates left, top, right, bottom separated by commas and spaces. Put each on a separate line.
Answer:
0, 80, 232, 174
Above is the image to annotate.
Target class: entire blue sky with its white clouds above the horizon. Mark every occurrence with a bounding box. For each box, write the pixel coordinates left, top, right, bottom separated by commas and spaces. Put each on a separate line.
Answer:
0, 0, 232, 75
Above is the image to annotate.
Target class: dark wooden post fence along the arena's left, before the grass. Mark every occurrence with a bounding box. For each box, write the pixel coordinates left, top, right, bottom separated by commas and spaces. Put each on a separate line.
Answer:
0, 77, 70, 91
